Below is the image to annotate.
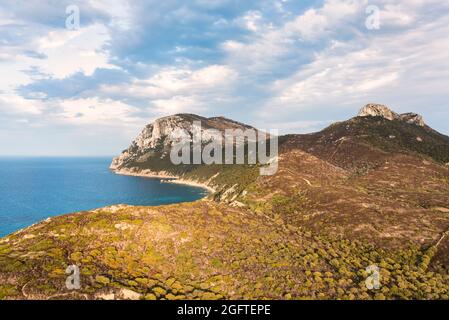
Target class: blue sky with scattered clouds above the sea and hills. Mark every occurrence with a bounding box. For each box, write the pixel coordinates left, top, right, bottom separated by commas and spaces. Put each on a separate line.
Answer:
0, 0, 449, 156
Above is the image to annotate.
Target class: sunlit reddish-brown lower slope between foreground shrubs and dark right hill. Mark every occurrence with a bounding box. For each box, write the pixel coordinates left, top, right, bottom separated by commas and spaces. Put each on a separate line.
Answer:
243, 146, 449, 248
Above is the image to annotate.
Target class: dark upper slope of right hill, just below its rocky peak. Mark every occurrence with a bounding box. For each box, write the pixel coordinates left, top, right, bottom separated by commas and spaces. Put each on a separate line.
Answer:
289, 117, 449, 170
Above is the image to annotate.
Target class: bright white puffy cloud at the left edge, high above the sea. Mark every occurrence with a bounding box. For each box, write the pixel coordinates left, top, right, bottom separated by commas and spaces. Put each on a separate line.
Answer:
0, 24, 117, 98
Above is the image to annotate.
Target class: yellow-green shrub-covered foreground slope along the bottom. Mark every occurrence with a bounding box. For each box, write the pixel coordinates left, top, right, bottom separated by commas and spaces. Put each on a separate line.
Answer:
0, 201, 449, 300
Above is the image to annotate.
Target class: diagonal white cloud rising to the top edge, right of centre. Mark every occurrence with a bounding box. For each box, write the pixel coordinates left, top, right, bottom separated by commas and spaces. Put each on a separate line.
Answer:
222, 0, 367, 73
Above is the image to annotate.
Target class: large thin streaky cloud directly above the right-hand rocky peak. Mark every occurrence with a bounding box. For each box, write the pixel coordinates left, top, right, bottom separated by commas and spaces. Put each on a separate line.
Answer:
261, 5, 449, 118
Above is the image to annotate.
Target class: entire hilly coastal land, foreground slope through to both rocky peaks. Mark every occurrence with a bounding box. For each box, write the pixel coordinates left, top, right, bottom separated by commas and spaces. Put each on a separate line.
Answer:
0, 104, 449, 300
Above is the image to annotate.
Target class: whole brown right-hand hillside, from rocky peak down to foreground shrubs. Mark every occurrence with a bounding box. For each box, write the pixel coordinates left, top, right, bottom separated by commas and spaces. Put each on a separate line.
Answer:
245, 110, 449, 262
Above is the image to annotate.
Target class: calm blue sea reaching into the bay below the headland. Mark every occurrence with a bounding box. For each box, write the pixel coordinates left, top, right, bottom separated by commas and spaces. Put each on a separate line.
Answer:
0, 157, 207, 237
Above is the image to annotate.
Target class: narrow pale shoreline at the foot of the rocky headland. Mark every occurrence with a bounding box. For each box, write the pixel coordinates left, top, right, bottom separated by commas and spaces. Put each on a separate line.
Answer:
111, 169, 216, 194
